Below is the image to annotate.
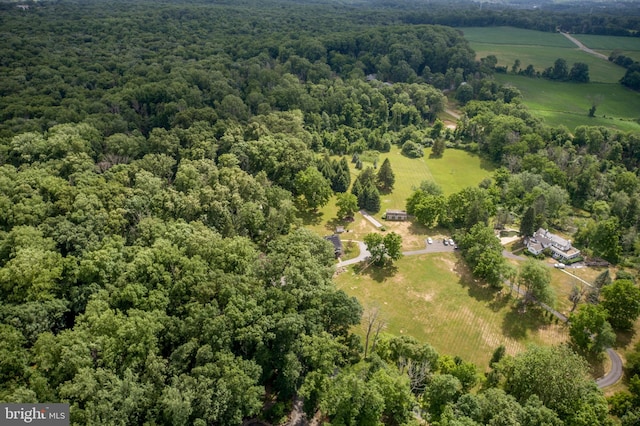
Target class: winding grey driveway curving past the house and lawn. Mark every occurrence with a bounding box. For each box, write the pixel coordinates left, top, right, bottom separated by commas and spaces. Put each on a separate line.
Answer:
337, 240, 622, 389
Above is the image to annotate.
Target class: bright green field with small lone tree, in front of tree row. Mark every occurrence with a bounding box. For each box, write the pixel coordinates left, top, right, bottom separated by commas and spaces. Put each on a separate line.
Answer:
496, 74, 640, 132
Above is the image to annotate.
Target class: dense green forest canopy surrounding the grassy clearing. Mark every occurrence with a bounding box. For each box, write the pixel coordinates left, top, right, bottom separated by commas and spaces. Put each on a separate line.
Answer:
0, 0, 640, 425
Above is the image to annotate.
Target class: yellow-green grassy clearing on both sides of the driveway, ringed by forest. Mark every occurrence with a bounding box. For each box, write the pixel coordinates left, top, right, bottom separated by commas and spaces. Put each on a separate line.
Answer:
303, 147, 570, 369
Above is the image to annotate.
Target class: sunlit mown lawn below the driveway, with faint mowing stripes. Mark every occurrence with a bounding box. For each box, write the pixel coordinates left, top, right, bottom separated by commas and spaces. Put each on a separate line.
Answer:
335, 253, 568, 369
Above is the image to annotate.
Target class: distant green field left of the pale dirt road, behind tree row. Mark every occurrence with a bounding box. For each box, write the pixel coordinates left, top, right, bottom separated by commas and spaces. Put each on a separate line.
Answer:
462, 27, 625, 83
